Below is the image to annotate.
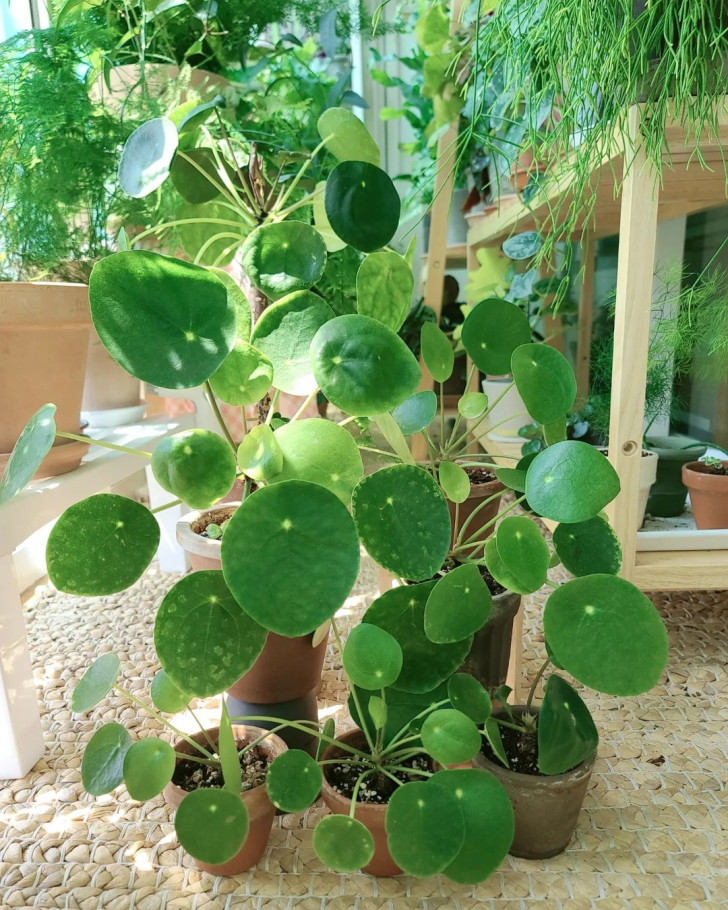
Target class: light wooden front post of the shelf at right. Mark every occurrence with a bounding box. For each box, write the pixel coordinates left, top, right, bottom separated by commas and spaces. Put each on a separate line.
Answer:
608, 107, 659, 578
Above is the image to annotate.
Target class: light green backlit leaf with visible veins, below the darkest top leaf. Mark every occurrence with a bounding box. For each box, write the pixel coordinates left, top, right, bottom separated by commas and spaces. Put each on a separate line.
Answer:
356, 251, 415, 332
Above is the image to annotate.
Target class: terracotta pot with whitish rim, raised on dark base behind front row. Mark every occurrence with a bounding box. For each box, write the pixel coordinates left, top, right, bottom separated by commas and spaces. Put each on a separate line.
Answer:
177, 503, 328, 704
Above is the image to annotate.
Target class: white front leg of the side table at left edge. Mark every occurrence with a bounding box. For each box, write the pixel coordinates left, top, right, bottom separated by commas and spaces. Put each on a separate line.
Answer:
0, 553, 44, 779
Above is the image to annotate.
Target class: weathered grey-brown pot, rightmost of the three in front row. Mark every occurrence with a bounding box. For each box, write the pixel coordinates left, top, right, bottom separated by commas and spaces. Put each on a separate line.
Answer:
473, 706, 596, 859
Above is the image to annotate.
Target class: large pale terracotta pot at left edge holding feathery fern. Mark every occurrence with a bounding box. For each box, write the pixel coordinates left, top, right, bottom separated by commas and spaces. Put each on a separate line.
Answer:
0, 281, 91, 456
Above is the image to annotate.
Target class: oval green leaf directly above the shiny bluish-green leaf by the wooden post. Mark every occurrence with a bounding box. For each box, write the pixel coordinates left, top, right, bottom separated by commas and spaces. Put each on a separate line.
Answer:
511, 344, 576, 424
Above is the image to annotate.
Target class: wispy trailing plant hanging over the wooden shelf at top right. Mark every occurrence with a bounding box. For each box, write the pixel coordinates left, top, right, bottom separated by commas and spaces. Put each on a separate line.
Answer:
464, 0, 728, 264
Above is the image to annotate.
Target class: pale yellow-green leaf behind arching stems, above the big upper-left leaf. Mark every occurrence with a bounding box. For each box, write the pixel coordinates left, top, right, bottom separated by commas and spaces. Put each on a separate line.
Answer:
175, 200, 250, 266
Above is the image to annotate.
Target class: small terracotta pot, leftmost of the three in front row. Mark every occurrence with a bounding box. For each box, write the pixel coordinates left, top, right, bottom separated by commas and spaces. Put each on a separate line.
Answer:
163, 724, 288, 875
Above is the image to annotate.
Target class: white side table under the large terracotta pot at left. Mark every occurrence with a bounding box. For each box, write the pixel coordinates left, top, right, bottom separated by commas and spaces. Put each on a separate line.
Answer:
0, 415, 195, 779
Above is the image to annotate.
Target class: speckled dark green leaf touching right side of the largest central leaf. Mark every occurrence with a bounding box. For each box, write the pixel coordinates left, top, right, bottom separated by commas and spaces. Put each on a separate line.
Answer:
352, 464, 452, 581
